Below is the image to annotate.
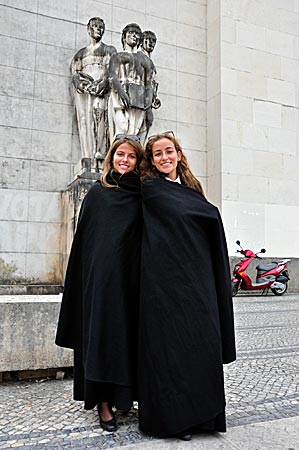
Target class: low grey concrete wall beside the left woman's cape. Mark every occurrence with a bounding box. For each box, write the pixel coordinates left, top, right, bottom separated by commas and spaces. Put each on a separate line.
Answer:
0, 295, 73, 372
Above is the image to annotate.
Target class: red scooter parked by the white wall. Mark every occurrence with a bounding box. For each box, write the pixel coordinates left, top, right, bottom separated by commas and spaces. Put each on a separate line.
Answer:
232, 241, 290, 297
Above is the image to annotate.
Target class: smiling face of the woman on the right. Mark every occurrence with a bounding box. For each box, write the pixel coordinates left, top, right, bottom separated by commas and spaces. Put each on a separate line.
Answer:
152, 137, 182, 180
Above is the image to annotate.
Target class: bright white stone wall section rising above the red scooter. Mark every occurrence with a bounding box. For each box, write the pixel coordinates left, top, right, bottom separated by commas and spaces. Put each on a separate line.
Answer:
220, 0, 299, 257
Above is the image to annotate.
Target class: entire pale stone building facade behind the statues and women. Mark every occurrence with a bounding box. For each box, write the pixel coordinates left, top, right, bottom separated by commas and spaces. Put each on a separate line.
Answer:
0, 0, 299, 284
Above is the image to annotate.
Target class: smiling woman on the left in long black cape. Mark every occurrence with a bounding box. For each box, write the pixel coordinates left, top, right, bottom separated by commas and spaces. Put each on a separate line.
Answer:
56, 135, 143, 431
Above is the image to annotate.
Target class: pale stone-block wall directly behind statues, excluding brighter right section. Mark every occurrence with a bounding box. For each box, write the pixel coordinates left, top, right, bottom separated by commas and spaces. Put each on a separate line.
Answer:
0, 0, 207, 284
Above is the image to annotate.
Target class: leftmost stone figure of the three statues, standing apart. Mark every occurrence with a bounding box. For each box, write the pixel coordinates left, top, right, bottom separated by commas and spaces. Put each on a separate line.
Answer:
71, 17, 116, 167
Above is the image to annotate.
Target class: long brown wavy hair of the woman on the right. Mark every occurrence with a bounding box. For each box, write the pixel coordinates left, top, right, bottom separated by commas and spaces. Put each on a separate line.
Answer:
141, 133, 205, 195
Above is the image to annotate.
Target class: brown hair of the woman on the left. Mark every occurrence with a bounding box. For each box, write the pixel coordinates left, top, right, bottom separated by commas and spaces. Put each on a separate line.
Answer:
101, 136, 144, 188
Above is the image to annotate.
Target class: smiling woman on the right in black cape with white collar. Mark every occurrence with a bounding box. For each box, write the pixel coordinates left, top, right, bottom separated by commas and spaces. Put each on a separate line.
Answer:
138, 132, 236, 440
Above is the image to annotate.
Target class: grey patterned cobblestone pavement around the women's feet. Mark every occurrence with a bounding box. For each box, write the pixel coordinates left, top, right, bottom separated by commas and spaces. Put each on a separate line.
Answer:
0, 294, 299, 450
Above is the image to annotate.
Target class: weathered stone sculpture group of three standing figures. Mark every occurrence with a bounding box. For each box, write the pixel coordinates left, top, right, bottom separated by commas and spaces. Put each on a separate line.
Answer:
71, 17, 161, 172
